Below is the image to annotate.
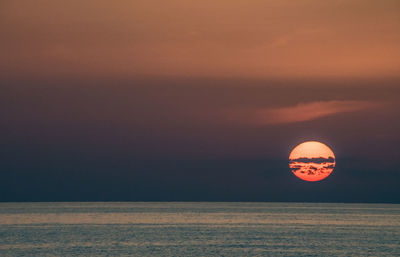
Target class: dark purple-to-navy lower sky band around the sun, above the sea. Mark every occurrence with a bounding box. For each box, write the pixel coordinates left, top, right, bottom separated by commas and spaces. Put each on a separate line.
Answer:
0, 78, 400, 202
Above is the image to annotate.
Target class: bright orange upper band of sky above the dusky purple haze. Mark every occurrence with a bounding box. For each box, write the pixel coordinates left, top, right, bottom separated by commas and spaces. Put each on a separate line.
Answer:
0, 0, 400, 78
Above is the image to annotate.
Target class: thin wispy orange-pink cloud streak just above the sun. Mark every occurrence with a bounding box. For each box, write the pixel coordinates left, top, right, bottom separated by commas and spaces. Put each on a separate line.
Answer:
250, 101, 378, 124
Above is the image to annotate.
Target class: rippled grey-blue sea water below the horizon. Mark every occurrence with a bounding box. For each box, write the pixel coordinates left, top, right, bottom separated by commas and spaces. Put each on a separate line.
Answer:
0, 202, 400, 256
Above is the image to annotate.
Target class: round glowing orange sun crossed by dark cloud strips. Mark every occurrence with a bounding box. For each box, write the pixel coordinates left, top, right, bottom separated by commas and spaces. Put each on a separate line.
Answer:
289, 141, 336, 181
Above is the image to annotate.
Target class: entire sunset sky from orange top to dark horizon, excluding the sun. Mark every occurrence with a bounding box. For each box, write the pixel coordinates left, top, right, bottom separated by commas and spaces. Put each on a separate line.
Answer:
0, 0, 400, 203
